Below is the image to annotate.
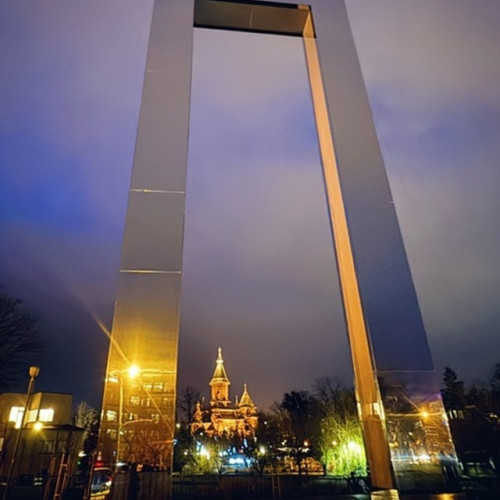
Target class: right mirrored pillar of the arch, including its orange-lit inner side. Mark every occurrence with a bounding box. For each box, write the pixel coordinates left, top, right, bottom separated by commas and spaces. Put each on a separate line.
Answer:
296, 0, 457, 491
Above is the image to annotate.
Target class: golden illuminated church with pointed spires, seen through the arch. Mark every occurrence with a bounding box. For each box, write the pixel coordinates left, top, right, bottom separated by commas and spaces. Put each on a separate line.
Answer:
191, 347, 259, 438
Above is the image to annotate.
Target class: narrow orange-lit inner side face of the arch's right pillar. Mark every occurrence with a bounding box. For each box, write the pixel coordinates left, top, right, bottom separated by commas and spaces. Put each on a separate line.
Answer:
303, 14, 393, 488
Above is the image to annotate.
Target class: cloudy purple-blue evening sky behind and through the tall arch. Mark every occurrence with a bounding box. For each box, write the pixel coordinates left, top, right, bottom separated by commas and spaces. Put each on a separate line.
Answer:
0, 0, 500, 408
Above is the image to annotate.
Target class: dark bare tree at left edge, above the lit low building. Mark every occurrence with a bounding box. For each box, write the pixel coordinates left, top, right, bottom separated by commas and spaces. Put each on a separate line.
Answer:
0, 287, 42, 392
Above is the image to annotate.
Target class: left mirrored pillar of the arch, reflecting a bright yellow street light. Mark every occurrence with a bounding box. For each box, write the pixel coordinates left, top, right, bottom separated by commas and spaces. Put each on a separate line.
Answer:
99, 0, 194, 470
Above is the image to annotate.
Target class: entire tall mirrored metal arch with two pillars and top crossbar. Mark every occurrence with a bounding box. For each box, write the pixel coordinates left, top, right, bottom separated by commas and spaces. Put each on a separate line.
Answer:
100, 0, 455, 489
